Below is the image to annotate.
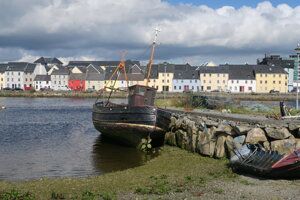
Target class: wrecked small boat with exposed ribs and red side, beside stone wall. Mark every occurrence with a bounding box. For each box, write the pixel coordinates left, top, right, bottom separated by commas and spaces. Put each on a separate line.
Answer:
231, 143, 300, 179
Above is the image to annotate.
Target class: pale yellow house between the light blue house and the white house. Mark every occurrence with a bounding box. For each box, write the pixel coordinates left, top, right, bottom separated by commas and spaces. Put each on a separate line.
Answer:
199, 66, 229, 92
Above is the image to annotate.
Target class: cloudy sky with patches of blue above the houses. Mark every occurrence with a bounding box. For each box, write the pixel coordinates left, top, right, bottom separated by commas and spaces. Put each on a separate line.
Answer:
0, 0, 300, 65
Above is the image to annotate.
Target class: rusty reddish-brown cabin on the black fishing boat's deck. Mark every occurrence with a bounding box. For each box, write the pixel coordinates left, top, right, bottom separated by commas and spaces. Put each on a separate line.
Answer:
128, 85, 157, 106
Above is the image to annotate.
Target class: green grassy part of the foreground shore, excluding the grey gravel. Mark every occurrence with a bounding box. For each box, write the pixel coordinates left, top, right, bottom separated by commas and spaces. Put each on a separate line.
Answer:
0, 146, 238, 200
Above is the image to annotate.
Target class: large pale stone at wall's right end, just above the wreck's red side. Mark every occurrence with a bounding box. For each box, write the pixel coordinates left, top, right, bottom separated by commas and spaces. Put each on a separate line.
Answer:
271, 139, 300, 155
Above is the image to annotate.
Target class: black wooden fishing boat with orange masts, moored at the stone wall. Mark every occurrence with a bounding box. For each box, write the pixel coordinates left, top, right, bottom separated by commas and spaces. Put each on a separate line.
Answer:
92, 30, 171, 148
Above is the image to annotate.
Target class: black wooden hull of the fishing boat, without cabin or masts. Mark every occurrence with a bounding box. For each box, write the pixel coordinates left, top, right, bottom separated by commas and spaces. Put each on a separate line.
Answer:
93, 103, 171, 147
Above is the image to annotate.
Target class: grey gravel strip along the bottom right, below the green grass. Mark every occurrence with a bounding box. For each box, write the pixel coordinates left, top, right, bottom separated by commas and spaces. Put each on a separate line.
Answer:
118, 176, 300, 200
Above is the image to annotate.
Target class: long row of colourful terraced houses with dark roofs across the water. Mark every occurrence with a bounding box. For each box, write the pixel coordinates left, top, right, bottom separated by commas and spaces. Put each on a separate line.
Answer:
0, 55, 300, 93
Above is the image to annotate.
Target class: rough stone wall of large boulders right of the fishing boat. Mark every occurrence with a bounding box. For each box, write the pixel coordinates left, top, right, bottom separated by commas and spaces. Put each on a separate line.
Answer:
165, 115, 300, 158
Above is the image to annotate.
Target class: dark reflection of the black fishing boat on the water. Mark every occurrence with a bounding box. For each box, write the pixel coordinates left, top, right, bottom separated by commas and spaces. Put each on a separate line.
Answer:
92, 135, 158, 173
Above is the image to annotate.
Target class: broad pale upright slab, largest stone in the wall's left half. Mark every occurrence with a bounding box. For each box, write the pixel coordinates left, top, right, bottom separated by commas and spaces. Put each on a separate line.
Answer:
197, 127, 217, 157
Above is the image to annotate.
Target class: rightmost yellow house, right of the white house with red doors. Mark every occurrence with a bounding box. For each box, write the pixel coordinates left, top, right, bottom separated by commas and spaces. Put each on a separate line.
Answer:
254, 65, 288, 93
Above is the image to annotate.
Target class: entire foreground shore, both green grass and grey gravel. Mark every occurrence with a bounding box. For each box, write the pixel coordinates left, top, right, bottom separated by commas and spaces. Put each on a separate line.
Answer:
0, 146, 300, 200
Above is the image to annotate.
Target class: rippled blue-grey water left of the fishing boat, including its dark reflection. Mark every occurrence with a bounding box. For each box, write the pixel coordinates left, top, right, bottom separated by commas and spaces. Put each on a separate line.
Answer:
0, 98, 154, 181
